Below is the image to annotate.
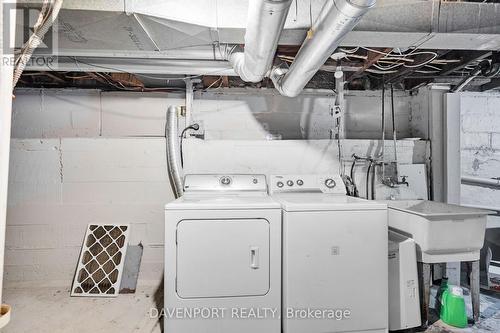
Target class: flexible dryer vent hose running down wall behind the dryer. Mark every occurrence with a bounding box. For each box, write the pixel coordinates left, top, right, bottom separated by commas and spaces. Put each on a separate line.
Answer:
165, 105, 184, 198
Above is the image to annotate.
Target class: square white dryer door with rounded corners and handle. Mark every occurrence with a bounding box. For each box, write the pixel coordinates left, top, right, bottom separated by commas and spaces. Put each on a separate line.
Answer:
177, 219, 269, 298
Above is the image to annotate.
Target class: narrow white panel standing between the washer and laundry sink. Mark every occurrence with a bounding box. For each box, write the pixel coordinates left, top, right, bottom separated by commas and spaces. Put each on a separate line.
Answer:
389, 231, 421, 331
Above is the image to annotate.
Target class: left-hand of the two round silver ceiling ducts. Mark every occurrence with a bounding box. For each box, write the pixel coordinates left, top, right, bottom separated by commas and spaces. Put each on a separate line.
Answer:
229, 0, 292, 82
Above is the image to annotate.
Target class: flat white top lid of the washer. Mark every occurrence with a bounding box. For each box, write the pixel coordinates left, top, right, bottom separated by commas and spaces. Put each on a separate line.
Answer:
273, 193, 387, 212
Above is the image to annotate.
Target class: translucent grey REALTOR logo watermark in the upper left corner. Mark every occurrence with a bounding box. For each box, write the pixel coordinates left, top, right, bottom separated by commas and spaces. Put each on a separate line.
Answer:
0, 0, 58, 69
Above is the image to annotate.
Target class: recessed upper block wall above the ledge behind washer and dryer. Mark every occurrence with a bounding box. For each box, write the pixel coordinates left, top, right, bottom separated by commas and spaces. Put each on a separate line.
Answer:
193, 89, 412, 140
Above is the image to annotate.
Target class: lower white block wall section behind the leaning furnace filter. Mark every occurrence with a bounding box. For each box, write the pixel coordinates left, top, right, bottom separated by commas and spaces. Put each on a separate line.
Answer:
5, 138, 173, 285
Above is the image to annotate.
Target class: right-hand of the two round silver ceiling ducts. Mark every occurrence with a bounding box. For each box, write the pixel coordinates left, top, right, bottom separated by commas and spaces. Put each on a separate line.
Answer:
271, 0, 376, 97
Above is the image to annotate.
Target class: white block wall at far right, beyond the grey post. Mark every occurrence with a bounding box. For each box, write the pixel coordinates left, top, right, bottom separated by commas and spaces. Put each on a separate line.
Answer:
460, 93, 500, 208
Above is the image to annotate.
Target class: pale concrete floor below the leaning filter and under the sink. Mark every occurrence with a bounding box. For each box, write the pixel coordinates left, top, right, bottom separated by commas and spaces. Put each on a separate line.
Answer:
2, 284, 500, 333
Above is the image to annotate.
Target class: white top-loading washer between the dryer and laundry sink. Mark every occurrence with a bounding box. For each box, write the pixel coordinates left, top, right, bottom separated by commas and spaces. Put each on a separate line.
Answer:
269, 175, 388, 333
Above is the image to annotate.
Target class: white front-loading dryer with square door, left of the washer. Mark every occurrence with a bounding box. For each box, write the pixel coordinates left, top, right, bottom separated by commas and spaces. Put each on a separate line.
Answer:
163, 175, 281, 333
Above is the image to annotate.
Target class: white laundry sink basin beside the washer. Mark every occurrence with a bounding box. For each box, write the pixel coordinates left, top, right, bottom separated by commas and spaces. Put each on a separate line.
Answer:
387, 200, 494, 263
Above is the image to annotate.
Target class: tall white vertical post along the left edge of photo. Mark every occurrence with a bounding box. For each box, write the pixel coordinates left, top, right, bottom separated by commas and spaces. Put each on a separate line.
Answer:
0, 2, 16, 322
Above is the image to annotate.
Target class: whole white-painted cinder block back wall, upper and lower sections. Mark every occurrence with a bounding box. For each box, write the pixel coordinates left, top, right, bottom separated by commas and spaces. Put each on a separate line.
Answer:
5, 89, 427, 286
